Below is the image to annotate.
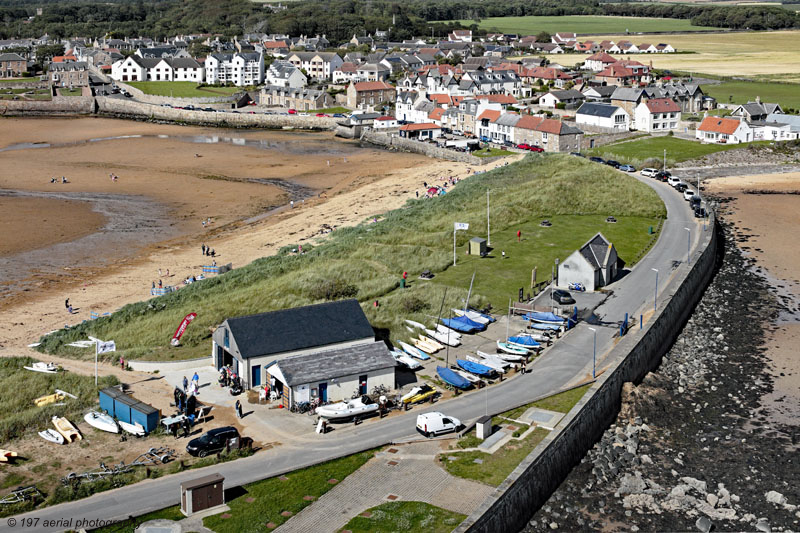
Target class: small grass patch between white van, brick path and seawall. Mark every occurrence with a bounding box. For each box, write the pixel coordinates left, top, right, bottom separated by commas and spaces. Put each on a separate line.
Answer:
439, 428, 550, 487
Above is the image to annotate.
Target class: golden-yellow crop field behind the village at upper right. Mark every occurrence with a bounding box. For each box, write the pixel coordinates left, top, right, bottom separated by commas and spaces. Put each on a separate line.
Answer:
549, 30, 800, 81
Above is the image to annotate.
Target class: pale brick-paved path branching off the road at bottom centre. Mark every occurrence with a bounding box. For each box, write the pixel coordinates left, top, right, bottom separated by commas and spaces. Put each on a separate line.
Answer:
276, 441, 494, 533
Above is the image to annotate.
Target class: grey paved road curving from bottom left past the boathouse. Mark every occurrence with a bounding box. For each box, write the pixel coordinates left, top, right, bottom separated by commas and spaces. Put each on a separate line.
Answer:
0, 169, 702, 533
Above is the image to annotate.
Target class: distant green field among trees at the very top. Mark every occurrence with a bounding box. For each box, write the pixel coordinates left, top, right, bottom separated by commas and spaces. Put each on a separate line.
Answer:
440, 15, 718, 35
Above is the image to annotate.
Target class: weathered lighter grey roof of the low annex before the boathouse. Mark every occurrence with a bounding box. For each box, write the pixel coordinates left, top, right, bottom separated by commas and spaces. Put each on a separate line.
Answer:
275, 342, 396, 387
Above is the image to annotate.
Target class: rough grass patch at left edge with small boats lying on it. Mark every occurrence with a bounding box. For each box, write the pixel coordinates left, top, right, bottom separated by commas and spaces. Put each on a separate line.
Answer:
0, 357, 119, 442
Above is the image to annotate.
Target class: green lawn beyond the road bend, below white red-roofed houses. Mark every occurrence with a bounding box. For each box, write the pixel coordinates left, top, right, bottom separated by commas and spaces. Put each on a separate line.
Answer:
586, 136, 762, 166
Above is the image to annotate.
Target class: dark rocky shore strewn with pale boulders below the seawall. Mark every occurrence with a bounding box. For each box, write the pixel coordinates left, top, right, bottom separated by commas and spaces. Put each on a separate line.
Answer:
524, 205, 800, 533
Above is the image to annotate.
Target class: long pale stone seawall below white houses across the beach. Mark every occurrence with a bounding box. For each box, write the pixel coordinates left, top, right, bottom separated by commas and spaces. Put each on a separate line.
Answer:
96, 96, 336, 130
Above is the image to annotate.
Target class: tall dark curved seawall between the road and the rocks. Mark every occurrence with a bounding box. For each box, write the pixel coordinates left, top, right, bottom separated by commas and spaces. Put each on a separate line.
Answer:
455, 214, 718, 533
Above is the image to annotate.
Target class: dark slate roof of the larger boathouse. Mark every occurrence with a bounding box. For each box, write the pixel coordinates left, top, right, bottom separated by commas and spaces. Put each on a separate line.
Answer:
227, 299, 375, 358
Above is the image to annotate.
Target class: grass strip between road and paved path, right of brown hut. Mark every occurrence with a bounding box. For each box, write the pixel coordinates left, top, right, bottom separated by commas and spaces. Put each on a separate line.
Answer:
203, 451, 375, 533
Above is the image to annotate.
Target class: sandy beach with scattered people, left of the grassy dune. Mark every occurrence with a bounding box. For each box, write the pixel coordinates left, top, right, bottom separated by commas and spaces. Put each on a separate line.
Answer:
0, 119, 502, 358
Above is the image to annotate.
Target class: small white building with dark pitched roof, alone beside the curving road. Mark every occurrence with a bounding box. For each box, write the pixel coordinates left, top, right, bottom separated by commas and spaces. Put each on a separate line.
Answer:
558, 233, 620, 291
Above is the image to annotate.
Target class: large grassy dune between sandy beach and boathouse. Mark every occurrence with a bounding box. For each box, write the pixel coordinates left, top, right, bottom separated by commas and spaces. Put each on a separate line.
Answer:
40, 154, 665, 360
